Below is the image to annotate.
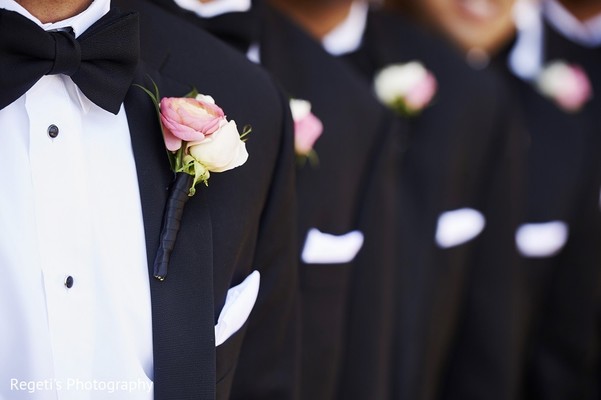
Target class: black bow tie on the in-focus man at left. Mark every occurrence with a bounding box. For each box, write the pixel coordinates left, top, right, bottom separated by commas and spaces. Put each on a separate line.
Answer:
0, 10, 140, 114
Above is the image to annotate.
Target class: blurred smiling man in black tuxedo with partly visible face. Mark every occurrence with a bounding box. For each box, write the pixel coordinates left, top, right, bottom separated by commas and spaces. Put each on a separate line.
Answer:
394, 1, 601, 400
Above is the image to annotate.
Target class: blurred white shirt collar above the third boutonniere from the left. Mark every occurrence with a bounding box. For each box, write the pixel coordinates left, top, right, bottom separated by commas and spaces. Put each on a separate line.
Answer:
321, 1, 369, 56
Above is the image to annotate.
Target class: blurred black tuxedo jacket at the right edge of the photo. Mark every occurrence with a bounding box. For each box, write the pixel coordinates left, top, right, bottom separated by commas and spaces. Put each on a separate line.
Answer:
506, 25, 601, 400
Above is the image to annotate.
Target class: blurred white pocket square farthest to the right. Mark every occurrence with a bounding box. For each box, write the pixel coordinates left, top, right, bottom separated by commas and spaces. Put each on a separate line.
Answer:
515, 221, 569, 258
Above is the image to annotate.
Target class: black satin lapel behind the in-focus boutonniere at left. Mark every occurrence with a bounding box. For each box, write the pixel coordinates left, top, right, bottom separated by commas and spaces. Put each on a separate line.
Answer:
125, 62, 215, 400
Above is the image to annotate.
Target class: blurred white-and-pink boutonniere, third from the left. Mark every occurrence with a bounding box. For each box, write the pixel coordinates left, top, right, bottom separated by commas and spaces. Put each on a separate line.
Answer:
374, 61, 438, 116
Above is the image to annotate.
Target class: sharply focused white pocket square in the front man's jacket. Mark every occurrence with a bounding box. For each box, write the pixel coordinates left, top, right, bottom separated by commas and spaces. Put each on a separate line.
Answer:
215, 271, 261, 347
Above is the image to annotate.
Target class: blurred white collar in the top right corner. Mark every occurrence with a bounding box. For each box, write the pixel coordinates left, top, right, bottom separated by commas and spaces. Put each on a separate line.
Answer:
543, 0, 601, 47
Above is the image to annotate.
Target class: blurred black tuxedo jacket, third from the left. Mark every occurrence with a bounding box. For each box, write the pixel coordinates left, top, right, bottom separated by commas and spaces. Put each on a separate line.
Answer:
344, 10, 524, 400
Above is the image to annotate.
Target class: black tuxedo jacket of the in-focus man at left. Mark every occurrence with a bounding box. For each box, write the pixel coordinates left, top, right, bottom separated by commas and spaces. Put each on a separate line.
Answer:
113, 0, 298, 400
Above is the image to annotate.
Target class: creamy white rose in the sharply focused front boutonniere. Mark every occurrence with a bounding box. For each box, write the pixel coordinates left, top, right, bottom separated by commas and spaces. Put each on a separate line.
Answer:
188, 121, 248, 172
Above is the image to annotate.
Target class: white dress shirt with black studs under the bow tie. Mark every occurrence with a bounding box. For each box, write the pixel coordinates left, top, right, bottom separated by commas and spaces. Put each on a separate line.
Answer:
0, 0, 153, 400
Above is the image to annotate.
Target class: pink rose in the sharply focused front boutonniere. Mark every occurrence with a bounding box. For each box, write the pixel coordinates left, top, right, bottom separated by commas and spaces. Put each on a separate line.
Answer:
160, 95, 225, 151
